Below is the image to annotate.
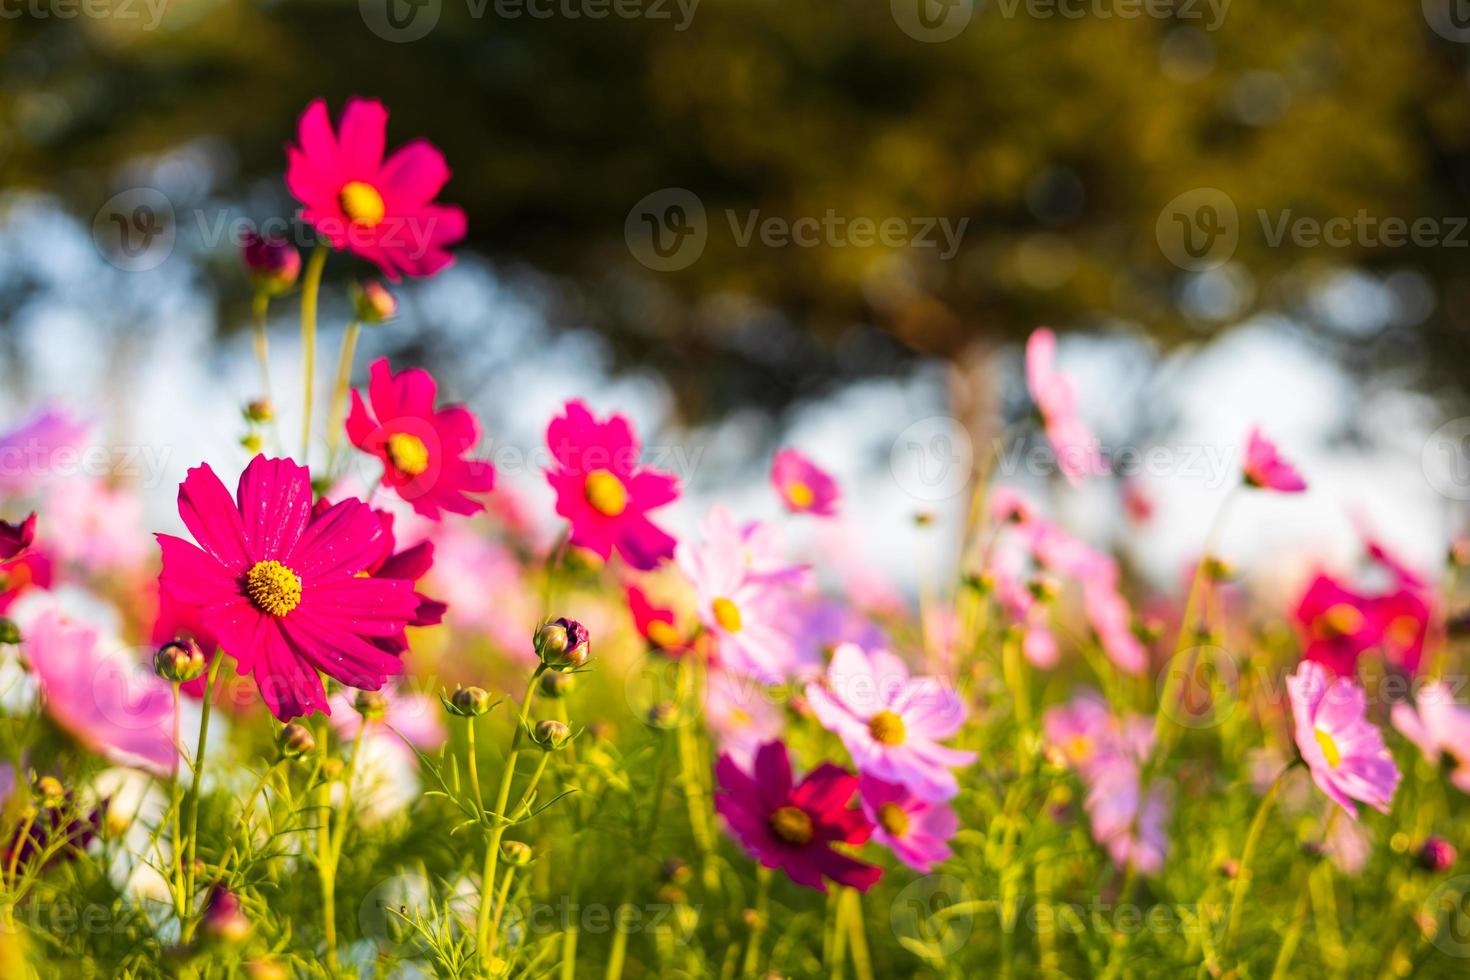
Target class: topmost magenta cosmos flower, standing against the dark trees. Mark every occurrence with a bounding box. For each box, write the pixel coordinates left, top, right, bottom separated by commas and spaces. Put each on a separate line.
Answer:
285, 98, 465, 282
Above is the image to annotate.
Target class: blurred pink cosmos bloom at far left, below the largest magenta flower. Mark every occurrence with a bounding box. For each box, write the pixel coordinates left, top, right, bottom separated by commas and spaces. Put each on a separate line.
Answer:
24, 610, 178, 774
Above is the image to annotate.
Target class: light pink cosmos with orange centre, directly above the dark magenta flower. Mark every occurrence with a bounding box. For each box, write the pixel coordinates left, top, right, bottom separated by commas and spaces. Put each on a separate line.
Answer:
807, 644, 976, 802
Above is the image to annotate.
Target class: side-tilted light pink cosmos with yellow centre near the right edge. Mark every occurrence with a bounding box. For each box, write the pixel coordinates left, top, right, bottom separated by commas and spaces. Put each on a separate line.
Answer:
1286, 660, 1401, 820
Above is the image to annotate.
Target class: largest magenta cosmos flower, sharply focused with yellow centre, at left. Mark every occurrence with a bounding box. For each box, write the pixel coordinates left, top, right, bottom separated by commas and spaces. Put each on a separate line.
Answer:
157, 455, 419, 720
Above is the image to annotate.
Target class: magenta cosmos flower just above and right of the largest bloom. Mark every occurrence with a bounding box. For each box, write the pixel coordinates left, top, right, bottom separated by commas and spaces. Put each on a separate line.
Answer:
347, 357, 495, 520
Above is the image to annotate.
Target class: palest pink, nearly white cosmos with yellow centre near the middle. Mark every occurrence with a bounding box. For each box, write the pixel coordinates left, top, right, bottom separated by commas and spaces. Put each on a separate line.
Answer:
678, 507, 816, 683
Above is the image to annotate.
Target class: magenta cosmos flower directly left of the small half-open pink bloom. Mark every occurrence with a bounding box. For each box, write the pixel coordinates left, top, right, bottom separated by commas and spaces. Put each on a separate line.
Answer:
545, 401, 679, 572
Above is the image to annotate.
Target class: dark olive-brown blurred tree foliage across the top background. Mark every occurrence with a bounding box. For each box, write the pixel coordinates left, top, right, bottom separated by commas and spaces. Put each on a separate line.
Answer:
0, 0, 1470, 416
